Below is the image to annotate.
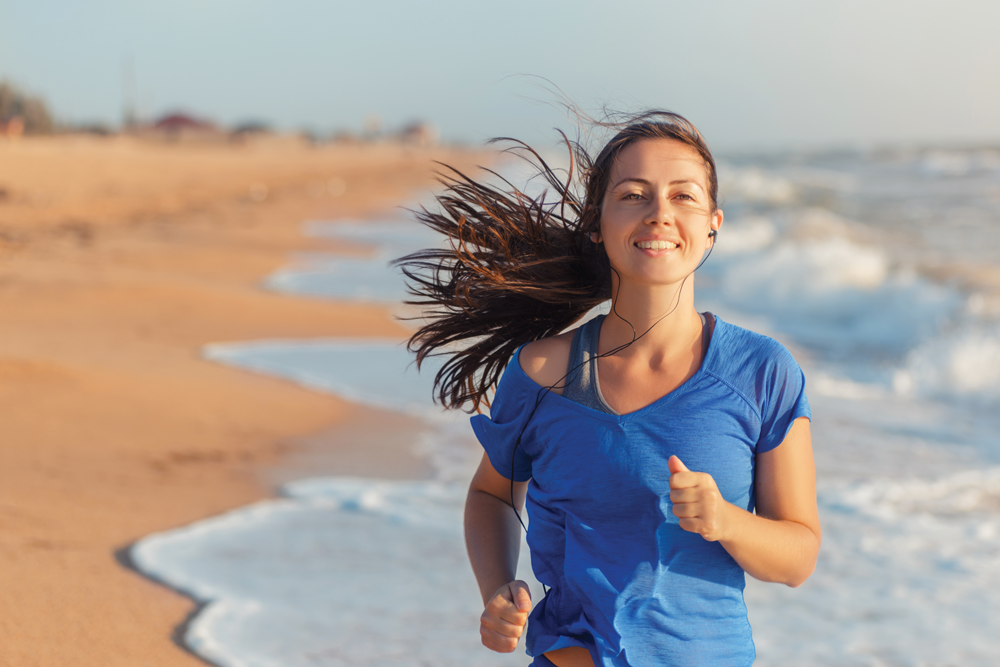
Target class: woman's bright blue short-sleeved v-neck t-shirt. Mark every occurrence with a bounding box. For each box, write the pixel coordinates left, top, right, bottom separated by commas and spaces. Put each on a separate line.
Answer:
472, 319, 810, 667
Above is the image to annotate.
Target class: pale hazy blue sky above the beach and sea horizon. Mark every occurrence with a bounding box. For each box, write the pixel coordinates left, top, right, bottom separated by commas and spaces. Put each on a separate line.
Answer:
0, 0, 1000, 149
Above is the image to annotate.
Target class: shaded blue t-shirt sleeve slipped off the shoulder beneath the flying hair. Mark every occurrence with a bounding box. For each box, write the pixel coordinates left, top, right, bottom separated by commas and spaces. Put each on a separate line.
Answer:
471, 354, 535, 482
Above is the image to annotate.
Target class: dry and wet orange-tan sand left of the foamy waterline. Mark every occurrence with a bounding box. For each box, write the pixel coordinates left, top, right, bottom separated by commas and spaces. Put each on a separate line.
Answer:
0, 137, 484, 667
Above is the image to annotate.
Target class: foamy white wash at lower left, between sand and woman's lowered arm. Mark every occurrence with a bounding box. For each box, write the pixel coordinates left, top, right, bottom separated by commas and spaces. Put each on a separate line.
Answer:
131, 478, 541, 667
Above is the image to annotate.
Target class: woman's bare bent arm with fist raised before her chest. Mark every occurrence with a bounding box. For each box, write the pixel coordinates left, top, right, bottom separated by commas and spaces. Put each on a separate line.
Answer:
669, 417, 821, 587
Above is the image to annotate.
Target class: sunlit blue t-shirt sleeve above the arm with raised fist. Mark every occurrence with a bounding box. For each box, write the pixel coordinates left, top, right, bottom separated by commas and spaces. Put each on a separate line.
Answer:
757, 345, 812, 454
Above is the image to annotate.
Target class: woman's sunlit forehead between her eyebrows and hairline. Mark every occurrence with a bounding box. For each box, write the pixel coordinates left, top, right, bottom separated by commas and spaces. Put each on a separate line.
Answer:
608, 139, 708, 190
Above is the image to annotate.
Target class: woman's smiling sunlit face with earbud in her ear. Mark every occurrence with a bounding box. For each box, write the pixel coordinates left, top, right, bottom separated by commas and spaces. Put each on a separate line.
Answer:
595, 139, 722, 285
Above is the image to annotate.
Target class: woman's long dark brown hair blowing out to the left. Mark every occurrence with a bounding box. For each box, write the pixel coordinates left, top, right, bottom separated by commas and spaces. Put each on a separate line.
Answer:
394, 111, 718, 411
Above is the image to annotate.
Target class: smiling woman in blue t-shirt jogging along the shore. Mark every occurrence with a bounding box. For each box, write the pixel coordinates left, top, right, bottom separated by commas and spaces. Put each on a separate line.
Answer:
400, 112, 820, 667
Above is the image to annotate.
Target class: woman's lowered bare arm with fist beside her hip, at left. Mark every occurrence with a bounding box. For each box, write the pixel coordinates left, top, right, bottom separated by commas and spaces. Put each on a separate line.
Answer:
465, 454, 531, 653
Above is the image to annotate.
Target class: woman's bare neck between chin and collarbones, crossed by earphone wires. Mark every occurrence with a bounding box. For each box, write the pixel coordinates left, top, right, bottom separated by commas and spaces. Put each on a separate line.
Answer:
601, 275, 702, 357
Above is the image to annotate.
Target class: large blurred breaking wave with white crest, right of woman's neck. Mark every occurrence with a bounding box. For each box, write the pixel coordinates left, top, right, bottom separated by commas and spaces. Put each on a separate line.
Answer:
709, 228, 961, 364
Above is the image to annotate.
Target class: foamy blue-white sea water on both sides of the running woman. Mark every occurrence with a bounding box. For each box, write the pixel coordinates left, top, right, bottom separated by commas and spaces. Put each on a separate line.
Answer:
132, 149, 1000, 667
